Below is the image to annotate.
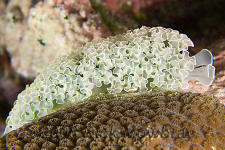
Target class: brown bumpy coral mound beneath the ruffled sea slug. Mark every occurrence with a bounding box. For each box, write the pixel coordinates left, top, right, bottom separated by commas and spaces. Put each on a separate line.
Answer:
0, 91, 225, 150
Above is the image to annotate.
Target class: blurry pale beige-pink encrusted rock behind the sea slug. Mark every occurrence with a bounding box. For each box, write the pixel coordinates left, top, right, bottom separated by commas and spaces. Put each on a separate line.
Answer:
0, 0, 110, 78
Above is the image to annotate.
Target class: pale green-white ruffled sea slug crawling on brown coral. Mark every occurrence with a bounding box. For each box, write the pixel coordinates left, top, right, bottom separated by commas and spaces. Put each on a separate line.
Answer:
5, 27, 215, 133
